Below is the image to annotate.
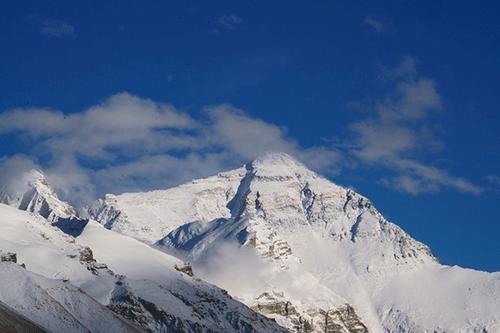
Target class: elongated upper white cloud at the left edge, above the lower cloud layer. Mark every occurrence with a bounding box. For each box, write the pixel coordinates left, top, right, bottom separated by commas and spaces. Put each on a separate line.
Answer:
0, 93, 196, 160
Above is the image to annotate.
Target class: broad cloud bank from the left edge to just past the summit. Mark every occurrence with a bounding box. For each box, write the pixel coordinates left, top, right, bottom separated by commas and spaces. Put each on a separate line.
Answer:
0, 93, 340, 203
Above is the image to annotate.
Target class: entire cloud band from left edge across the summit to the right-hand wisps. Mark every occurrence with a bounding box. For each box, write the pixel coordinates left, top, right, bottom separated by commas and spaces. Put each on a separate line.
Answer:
0, 57, 483, 205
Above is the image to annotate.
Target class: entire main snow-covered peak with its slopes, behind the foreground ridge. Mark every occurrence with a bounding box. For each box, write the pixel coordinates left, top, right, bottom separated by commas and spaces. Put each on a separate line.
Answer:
88, 154, 500, 332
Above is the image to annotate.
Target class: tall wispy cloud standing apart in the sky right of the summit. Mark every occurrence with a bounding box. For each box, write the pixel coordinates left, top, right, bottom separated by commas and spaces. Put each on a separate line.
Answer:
350, 57, 481, 194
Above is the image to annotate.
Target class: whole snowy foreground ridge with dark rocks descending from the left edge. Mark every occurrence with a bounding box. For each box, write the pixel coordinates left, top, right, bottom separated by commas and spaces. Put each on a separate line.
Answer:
0, 204, 282, 332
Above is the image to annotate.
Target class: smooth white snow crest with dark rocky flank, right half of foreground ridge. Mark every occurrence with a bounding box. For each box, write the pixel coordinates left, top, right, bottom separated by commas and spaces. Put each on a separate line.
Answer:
77, 221, 282, 332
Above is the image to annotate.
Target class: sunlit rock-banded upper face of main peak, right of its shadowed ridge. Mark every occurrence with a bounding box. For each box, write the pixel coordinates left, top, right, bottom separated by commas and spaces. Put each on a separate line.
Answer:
233, 154, 434, 271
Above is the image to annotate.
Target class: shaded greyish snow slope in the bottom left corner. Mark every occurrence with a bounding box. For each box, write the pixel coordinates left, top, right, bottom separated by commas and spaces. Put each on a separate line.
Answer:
0, 263, 139, 333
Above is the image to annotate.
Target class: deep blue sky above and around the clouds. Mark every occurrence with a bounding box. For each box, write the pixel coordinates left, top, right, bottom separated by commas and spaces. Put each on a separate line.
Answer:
0, 1, 500, 271
